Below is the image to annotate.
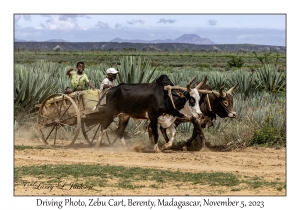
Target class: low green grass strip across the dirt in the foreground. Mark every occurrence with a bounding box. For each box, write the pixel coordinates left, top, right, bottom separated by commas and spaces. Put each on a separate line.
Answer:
14, 164, 285, 191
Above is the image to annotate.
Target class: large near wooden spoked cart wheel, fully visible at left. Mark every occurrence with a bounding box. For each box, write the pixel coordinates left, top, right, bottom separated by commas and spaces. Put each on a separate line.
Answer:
37, 93, 81, 147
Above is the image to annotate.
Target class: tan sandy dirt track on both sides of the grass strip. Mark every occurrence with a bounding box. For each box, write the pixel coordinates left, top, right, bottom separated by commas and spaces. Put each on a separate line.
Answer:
14, 138, 286, 196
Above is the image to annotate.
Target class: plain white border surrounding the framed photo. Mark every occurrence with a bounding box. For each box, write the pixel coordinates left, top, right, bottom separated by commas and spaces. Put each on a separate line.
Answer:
4, 0, 300, 209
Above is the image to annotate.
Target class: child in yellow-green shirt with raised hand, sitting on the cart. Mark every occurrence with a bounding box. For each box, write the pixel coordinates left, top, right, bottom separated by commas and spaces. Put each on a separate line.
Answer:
64, 62, 95, 94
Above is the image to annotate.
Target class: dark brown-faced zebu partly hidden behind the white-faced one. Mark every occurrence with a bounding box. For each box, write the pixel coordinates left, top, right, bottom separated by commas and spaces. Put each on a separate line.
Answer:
160, 78, 238, 150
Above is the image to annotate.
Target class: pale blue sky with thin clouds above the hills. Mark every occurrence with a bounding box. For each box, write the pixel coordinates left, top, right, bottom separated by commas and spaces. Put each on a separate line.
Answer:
14, 13, 286, 46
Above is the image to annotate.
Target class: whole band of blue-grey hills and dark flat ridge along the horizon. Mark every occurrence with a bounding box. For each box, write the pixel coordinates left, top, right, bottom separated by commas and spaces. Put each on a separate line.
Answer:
14, 34, 286, 52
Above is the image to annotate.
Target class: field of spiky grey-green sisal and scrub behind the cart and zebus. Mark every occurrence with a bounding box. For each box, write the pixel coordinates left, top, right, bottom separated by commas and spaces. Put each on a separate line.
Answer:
14, 51, 286, 147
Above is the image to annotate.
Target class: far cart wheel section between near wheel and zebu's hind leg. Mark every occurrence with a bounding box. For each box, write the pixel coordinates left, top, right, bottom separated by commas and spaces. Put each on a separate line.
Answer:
81, 121, 101, 146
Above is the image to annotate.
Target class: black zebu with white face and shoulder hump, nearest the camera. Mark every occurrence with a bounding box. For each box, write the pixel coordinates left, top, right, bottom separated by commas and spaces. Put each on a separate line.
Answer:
95, 75, 205, 152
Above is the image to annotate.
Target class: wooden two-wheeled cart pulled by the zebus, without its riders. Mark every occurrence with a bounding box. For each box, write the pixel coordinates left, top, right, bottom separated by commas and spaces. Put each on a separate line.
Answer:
37, 90, 110, 147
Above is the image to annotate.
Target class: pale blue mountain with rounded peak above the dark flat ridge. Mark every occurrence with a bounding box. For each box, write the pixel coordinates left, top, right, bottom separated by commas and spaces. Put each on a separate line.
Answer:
110, 34, 216, 44
